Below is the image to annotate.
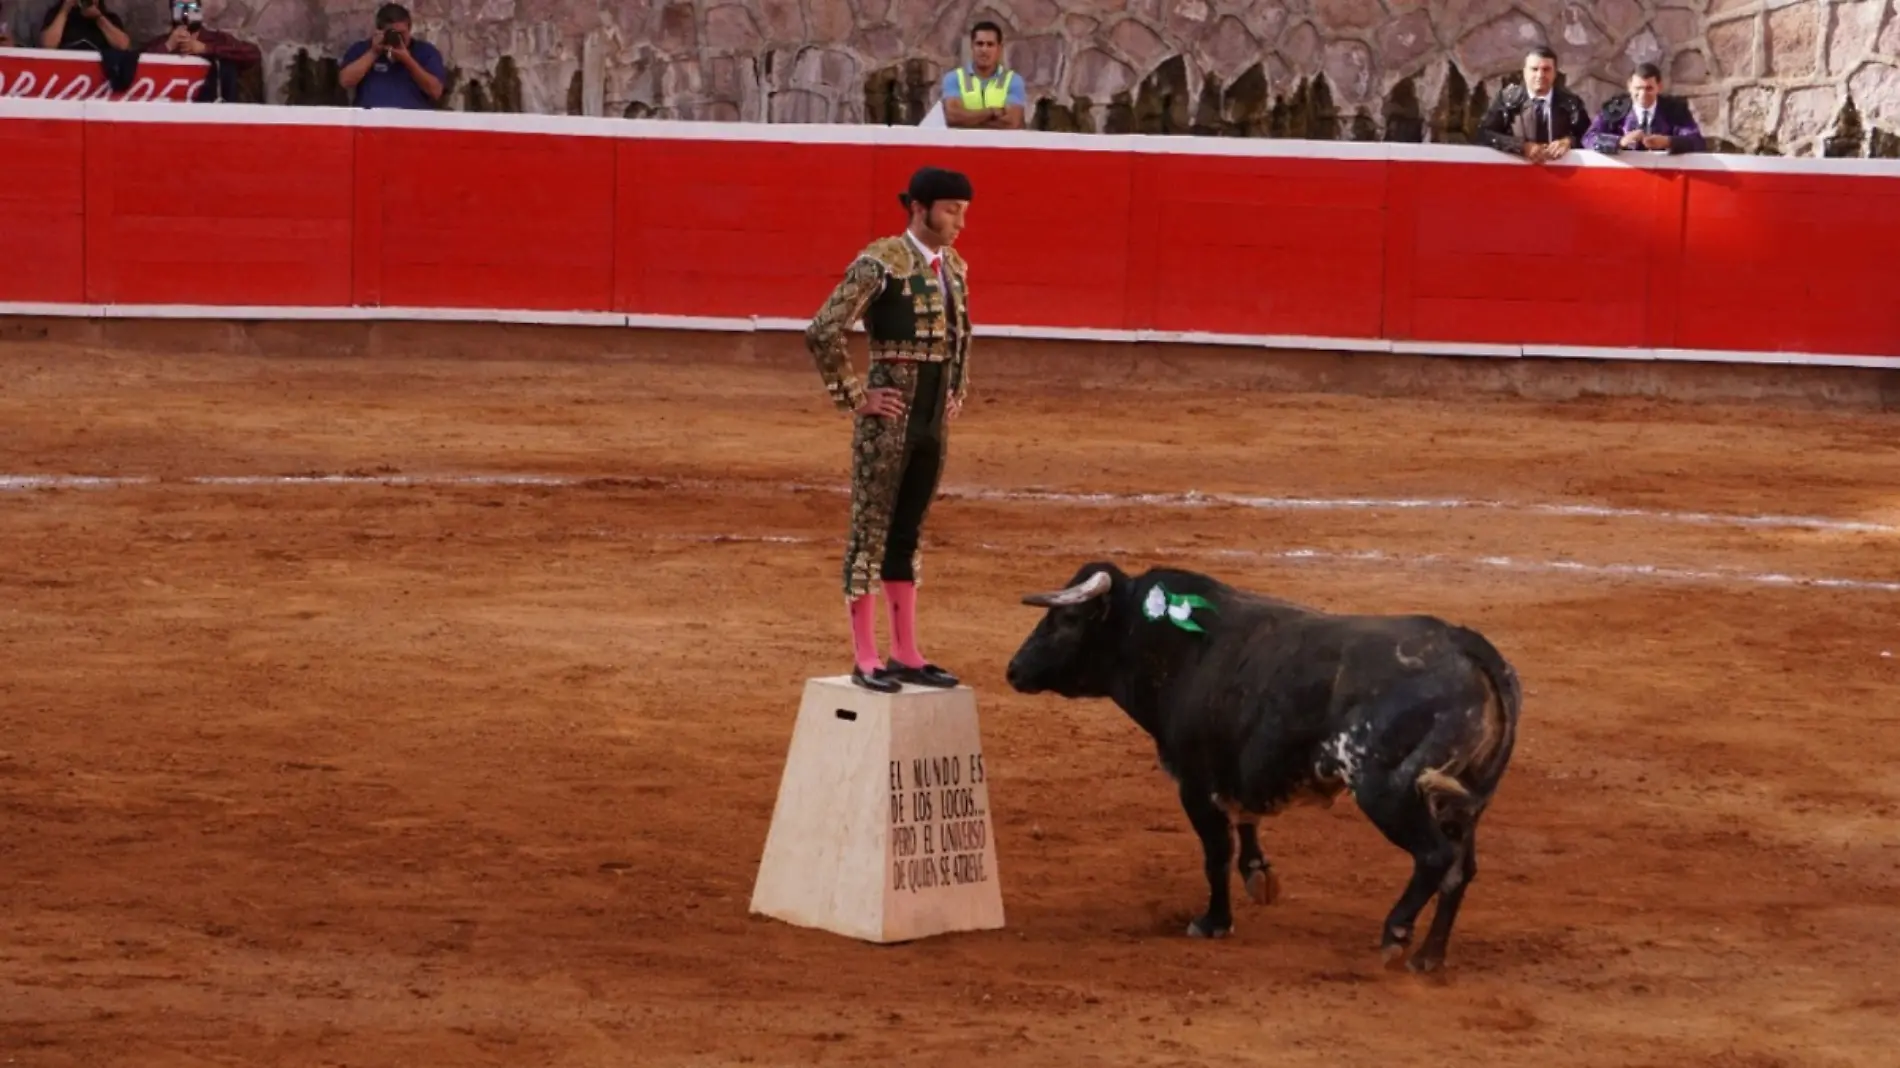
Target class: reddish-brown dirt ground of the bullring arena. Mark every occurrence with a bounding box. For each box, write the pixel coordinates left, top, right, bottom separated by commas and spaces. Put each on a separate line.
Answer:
0, 334, 1900, 1068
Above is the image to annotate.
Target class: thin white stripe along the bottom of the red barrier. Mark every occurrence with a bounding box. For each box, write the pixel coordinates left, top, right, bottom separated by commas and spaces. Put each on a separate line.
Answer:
0, 300, 1900, 371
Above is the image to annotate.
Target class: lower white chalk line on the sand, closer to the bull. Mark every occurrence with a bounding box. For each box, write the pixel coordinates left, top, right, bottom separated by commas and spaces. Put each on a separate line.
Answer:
650, 534, 1900, 593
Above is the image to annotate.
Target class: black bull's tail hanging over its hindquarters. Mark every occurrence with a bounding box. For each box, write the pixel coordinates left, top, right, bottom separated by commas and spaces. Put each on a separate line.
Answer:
1416, 627, 1524, 823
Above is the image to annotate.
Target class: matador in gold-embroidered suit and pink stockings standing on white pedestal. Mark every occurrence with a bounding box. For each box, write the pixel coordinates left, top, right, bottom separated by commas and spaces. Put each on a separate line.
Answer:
806, 158, 971, 694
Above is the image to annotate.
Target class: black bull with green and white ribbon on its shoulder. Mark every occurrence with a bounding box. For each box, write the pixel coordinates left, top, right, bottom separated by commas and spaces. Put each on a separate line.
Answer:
1009, 563, 1522, 971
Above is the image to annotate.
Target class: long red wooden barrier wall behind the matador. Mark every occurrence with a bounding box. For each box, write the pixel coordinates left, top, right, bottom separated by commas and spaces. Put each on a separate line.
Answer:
0, 105, 1900, 357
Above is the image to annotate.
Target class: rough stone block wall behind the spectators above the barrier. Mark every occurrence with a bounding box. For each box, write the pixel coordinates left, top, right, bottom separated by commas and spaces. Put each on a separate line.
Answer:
107, 0, 1900, 156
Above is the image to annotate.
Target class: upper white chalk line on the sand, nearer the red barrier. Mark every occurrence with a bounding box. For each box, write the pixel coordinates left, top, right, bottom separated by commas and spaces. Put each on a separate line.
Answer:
0, 473, 1900, 534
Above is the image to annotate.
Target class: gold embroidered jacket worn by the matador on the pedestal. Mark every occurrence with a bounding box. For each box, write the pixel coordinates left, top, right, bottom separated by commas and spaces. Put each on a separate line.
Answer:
806, 234, 969, 412
